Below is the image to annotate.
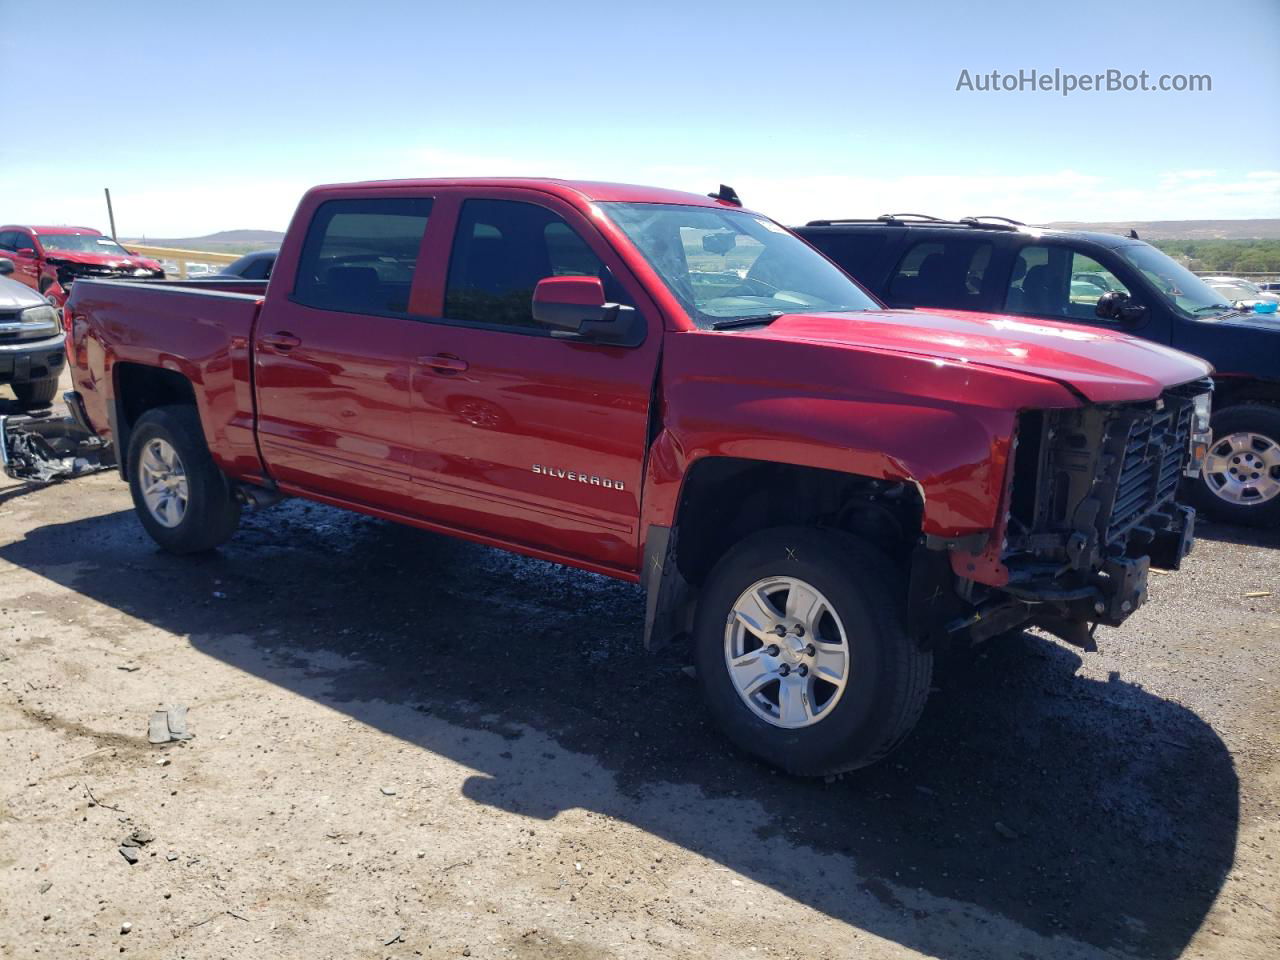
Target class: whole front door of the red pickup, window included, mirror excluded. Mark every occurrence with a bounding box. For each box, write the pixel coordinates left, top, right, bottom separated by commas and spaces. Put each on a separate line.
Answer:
401, 189, 662, 570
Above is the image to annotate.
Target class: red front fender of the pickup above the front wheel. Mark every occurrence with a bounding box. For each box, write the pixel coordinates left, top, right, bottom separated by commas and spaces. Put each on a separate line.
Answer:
641, 332, 1079, 555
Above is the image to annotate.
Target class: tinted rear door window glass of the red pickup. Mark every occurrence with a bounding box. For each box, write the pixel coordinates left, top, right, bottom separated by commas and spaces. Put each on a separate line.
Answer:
293, 197, 431, 316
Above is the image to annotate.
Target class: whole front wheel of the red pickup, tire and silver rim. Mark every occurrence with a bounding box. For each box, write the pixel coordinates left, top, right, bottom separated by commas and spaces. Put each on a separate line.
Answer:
694, 527, 933, 776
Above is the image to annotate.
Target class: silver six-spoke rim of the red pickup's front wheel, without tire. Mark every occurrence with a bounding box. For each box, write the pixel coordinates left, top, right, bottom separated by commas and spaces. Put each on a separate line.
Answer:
724, 576, 850, 730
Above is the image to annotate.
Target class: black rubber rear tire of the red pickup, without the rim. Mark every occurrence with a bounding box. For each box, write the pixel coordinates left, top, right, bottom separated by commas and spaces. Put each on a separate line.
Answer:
127, 406, 241, 553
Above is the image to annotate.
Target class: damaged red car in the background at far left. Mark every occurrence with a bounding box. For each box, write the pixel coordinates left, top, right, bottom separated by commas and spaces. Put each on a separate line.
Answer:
0, 224, 164, 306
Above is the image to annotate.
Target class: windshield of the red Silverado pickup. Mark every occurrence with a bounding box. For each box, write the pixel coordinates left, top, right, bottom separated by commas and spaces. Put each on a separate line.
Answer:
599, 204, 879, 326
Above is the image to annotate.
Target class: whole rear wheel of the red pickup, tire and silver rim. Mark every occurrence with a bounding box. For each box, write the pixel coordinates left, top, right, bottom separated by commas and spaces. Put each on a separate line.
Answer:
127, 406, 241, 553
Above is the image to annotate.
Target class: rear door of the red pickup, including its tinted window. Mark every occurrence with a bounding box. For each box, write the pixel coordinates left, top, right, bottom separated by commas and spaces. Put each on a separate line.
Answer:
255, 191, 433, 513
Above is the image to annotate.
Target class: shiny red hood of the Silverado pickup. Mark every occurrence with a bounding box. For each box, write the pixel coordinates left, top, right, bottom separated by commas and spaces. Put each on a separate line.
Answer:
748, 310, 1212, 403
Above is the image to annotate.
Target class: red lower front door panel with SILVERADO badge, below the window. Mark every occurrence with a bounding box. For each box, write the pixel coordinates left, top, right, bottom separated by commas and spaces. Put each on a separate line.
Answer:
412, 325, 660, 570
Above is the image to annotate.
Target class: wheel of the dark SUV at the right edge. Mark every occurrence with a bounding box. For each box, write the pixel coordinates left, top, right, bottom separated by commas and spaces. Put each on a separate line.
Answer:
1196, 403, 1280, 526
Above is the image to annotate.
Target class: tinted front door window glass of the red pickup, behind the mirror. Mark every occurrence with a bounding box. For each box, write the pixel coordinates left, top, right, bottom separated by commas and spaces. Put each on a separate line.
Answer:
444, 200, 611, 329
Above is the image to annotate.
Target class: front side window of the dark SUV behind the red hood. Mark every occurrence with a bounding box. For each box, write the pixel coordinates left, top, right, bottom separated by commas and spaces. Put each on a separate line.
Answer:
1005, 246, 1129, 321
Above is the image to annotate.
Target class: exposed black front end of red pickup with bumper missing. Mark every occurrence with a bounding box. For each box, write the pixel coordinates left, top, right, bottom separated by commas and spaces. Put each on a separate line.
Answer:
913, 380, 1212, 649
